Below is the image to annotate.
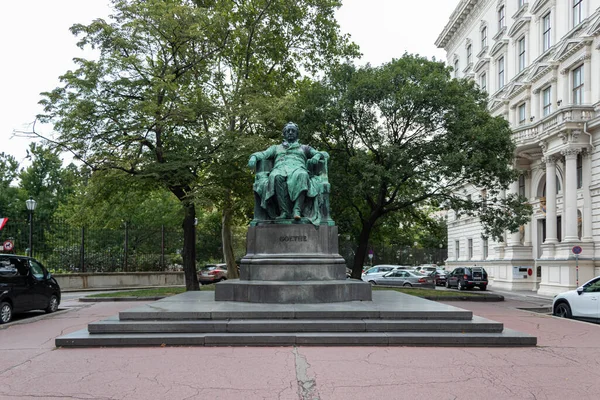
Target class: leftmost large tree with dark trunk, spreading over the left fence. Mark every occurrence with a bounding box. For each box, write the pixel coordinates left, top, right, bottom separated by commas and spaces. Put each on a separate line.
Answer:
40, 0, 237, 290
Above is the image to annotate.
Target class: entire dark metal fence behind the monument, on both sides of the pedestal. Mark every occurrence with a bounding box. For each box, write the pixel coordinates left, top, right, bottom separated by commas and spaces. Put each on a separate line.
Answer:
0, 219, 448, 272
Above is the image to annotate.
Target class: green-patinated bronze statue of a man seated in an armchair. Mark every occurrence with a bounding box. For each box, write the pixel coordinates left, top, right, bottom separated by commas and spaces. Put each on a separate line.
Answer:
248, 122, 335, 225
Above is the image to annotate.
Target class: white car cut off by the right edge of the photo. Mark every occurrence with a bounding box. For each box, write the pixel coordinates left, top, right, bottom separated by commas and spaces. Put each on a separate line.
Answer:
552, 276, 600, 321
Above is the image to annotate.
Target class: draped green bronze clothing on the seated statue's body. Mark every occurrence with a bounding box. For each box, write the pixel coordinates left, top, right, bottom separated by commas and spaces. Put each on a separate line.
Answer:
252, 142, 320, 225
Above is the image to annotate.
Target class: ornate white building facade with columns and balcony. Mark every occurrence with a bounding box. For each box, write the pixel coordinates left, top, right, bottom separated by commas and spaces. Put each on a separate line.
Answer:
436, 0, 600, 295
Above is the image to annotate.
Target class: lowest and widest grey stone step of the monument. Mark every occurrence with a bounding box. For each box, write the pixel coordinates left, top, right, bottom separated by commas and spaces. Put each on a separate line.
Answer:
56, 329, 537, 347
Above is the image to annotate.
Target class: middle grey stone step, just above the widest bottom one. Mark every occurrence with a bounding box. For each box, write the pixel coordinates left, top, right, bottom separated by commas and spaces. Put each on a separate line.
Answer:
88, 316, 504, 334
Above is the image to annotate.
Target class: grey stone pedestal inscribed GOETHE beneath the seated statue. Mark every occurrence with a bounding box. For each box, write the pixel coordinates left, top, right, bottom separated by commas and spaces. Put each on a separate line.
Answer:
215, 224, 371, 303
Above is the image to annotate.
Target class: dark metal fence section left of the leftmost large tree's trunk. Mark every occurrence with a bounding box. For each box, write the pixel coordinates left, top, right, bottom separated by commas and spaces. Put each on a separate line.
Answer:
0, 219, 183, 272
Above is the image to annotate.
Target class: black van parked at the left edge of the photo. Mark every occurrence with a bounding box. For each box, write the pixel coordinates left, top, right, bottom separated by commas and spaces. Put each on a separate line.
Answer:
0, 254, 60, 324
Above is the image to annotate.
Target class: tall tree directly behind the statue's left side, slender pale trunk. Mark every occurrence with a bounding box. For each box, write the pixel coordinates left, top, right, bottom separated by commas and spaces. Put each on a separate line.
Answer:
195, 0, 358, 278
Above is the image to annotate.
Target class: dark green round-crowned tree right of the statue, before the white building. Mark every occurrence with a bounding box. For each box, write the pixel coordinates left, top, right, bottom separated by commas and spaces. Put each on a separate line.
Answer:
300, 55, 531, 278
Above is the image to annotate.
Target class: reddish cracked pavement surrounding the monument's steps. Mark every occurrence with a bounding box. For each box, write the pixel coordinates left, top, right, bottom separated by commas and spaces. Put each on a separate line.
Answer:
0, 299, 600, 400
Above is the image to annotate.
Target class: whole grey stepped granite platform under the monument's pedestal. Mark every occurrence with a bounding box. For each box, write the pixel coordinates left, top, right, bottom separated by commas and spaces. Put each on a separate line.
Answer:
55, 291, 537, 347
